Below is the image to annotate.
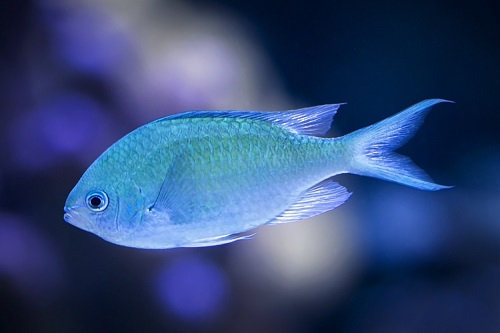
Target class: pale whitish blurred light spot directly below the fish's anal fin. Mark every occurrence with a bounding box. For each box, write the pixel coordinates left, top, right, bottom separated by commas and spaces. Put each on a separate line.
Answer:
232, 210, 362, 304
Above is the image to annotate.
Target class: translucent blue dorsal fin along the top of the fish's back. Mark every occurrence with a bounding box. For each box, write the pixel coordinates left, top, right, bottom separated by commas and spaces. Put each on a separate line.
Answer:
162, 104, 342, 136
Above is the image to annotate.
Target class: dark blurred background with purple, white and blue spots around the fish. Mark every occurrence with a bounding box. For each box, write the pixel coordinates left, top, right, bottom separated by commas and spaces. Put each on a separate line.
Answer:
0, 0, 500, 333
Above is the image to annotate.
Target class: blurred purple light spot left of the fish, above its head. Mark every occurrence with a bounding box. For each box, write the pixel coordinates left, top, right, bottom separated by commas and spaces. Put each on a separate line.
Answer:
9, 93, 109, 170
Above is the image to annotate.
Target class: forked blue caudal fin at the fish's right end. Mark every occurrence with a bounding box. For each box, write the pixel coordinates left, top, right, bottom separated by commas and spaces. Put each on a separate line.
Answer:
342, 99, 450, 191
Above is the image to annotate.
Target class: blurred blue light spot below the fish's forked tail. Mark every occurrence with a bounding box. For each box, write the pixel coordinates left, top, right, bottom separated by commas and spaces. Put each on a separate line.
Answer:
360, 186, 446, 266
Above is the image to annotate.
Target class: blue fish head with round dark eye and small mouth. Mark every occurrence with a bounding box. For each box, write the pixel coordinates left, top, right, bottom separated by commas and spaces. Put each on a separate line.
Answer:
64, 163, 144, 245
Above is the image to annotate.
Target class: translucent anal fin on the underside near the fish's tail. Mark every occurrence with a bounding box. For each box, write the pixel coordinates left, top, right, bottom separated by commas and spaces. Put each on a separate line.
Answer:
270, 180, 351, 224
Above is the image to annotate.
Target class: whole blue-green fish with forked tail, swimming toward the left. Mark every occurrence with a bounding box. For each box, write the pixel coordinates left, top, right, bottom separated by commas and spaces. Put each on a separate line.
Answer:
64, 99, 450, 249
